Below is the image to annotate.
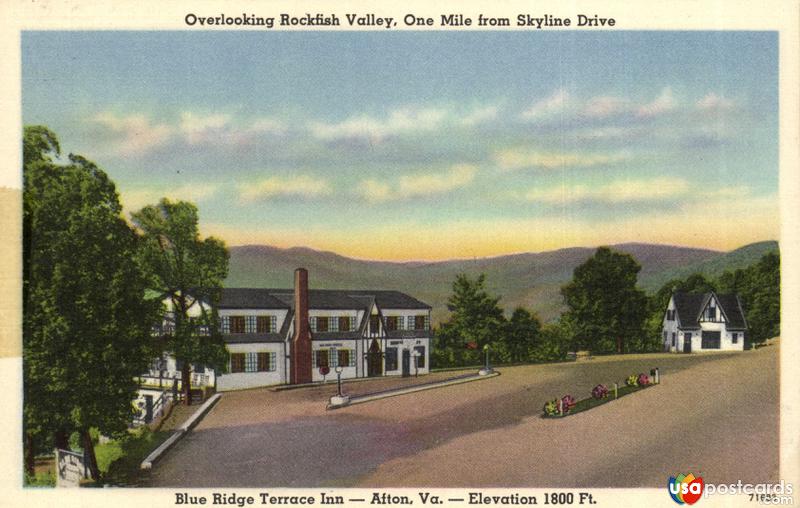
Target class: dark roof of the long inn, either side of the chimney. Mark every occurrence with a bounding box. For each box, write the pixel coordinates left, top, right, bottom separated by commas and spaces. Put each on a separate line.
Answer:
220, 288, 431, 310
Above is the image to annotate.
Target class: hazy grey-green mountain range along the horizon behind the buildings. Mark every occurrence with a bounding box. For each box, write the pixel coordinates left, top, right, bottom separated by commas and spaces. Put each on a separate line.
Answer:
225, 241, 778, 323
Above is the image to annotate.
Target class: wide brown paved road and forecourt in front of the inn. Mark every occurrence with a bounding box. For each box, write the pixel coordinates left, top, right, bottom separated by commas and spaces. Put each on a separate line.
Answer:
147, 345, 779, 488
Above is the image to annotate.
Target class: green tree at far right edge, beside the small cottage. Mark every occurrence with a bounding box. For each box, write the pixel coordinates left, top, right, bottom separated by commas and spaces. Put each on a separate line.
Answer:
719, 252, 781, 343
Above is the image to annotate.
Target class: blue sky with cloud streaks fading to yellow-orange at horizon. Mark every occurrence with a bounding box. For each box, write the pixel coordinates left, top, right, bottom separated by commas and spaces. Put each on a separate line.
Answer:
22, 31, 779, 261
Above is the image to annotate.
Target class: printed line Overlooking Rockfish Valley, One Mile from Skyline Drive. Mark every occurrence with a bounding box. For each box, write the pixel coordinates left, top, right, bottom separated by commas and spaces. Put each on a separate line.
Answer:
184, 13, 617, 30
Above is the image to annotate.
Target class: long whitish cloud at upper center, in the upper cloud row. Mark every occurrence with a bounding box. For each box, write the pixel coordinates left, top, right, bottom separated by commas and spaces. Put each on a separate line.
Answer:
308, 108, 447, 143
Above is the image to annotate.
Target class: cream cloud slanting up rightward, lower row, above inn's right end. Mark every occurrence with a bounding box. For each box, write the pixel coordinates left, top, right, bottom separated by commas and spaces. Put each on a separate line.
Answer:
357, 164, 478, 203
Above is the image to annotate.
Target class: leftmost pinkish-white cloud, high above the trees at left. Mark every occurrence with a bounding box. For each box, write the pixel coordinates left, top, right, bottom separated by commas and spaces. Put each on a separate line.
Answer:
90, 111, 175, 156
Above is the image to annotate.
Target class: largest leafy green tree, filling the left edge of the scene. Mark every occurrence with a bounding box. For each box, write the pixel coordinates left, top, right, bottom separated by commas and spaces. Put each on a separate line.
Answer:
23, 126, 157, 478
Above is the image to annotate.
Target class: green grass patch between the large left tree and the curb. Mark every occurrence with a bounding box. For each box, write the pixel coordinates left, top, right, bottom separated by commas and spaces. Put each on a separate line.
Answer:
95, 427, 172, 486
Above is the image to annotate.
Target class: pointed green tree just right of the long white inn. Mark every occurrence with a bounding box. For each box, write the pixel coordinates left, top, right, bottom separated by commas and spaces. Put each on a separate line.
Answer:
435, 273, 505, 365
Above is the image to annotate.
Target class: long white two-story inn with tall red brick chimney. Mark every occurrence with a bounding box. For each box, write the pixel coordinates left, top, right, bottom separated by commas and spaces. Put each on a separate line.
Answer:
144, 268, 431, 391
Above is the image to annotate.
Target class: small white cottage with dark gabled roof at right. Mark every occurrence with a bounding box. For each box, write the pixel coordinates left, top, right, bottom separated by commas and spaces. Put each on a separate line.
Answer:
662, 291, 747, 353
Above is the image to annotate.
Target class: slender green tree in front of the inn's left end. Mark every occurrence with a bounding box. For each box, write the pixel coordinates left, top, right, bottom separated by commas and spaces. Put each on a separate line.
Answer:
131, 198, 229, 404
